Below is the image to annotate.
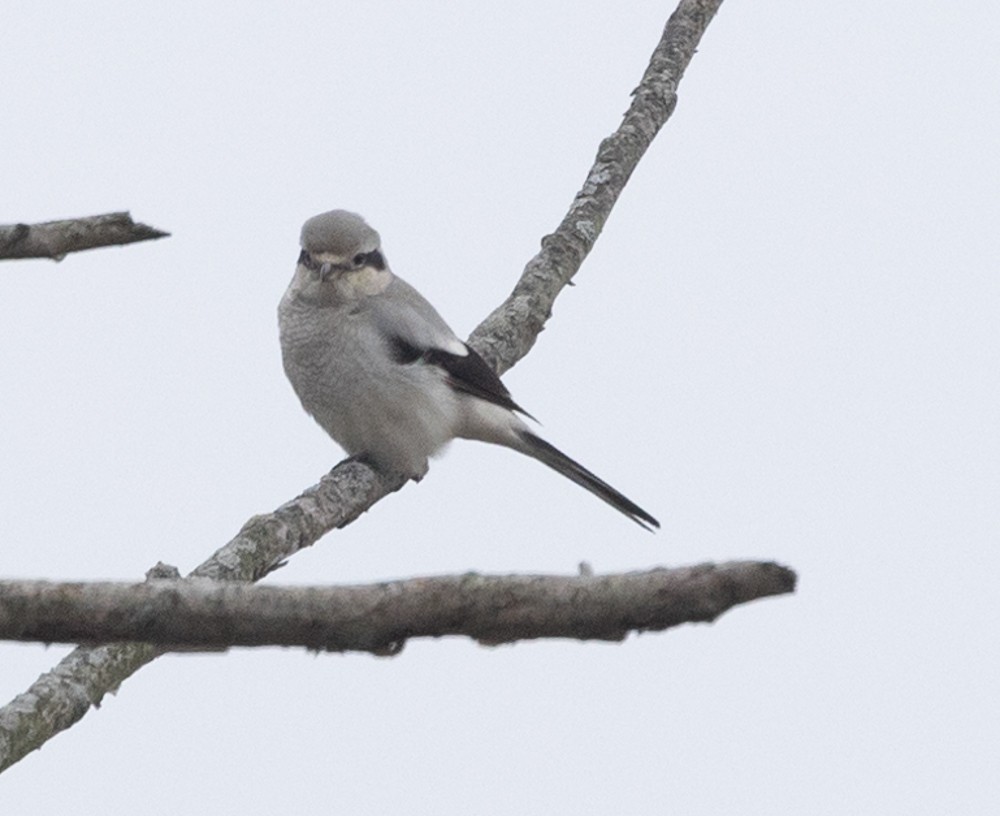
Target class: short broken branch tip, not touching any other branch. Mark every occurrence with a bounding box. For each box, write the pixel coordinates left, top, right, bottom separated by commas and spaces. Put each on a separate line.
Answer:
0, 212, 170, 261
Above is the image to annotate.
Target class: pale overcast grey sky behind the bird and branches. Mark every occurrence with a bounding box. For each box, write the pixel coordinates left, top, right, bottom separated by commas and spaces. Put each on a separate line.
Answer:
0, 0, 1000, 816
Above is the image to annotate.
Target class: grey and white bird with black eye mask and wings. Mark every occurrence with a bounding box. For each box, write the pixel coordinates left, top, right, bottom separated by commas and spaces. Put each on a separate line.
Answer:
278, 210, 660, 529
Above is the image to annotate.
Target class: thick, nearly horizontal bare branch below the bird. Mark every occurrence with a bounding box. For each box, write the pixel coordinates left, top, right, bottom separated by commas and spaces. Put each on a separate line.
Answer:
0, 561, 795, 654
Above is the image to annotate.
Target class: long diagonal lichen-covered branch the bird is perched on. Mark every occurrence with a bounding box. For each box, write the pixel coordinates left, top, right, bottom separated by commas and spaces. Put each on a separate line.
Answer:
0, 0, 736, 770
